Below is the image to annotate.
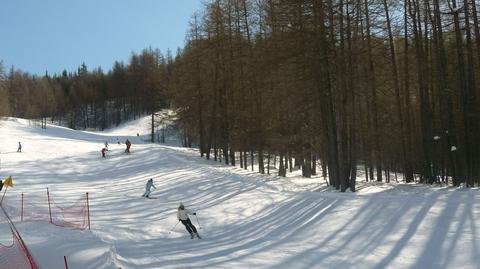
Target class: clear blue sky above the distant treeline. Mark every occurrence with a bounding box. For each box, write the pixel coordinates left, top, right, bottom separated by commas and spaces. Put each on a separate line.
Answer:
0, 0, 202, 75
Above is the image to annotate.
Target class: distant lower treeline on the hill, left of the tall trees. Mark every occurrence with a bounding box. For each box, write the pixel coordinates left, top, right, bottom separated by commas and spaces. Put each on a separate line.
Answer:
0, 49, 173, 130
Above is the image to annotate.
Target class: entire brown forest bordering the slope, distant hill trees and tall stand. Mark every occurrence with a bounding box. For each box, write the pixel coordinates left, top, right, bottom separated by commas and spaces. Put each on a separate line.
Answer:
0, 0, 480, 191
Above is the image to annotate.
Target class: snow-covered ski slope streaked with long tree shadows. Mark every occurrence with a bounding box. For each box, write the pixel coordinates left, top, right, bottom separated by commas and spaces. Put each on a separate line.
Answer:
0, 118, 480, 269
